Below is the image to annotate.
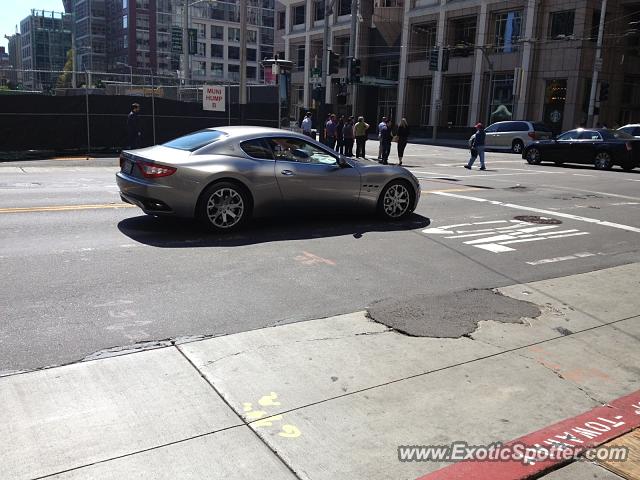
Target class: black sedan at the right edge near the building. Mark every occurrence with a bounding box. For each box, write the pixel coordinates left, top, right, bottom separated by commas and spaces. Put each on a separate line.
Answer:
522, 128, 640, 171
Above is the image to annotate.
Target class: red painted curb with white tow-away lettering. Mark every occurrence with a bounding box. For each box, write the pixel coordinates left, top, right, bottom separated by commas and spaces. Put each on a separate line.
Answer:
417, 390, 640, 480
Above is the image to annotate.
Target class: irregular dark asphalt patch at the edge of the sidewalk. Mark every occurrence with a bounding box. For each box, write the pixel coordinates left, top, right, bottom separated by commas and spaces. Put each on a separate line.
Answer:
367, 289, 541, 338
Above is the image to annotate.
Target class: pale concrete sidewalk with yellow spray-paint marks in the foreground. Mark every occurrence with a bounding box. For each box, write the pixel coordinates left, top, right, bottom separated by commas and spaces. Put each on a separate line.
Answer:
0, 264, 640, 480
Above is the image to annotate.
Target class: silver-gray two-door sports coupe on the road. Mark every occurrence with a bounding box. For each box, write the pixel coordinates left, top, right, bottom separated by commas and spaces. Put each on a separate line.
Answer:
116, 126, 420, 231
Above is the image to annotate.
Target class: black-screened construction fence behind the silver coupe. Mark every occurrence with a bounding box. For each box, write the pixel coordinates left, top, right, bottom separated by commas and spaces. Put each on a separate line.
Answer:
0, 70, 280, 155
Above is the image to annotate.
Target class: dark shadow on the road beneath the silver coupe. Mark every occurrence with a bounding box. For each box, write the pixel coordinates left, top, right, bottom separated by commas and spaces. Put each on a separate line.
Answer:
118, 213, 431, 248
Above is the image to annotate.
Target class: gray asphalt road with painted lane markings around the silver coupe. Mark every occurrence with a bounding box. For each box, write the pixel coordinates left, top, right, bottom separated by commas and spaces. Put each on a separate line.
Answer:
0, 142, 640, 373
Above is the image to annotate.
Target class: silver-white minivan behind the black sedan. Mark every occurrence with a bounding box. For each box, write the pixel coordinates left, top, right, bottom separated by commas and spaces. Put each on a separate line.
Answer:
485, 120, 553, 153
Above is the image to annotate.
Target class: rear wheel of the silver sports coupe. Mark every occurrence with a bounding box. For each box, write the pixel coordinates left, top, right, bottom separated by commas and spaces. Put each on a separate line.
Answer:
198, 182, 250, 232
